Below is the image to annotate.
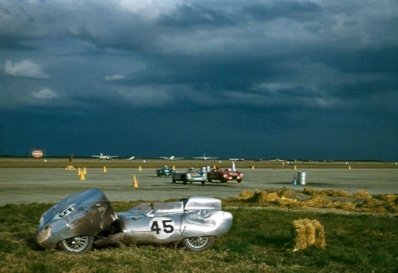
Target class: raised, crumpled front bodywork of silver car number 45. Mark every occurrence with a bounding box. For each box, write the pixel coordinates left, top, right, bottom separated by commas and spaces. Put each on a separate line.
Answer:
36, 189, 117, 248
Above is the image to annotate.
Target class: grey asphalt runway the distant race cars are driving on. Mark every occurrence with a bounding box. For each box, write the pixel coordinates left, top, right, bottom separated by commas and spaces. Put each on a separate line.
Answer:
0, 168, 398, 205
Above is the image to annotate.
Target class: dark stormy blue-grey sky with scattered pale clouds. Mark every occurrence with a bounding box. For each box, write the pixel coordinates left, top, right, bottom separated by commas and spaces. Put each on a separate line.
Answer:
0, 0, 398, 161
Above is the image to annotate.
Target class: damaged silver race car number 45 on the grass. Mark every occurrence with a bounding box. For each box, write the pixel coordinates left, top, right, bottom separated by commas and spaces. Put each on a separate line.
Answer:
36, 189, 233, 253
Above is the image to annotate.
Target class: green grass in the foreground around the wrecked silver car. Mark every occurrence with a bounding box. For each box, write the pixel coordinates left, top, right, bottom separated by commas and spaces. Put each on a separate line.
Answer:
0, 200, 398, 273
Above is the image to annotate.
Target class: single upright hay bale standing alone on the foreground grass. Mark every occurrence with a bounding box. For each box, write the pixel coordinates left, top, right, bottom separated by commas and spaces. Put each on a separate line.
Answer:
293, 218, 326, 251
